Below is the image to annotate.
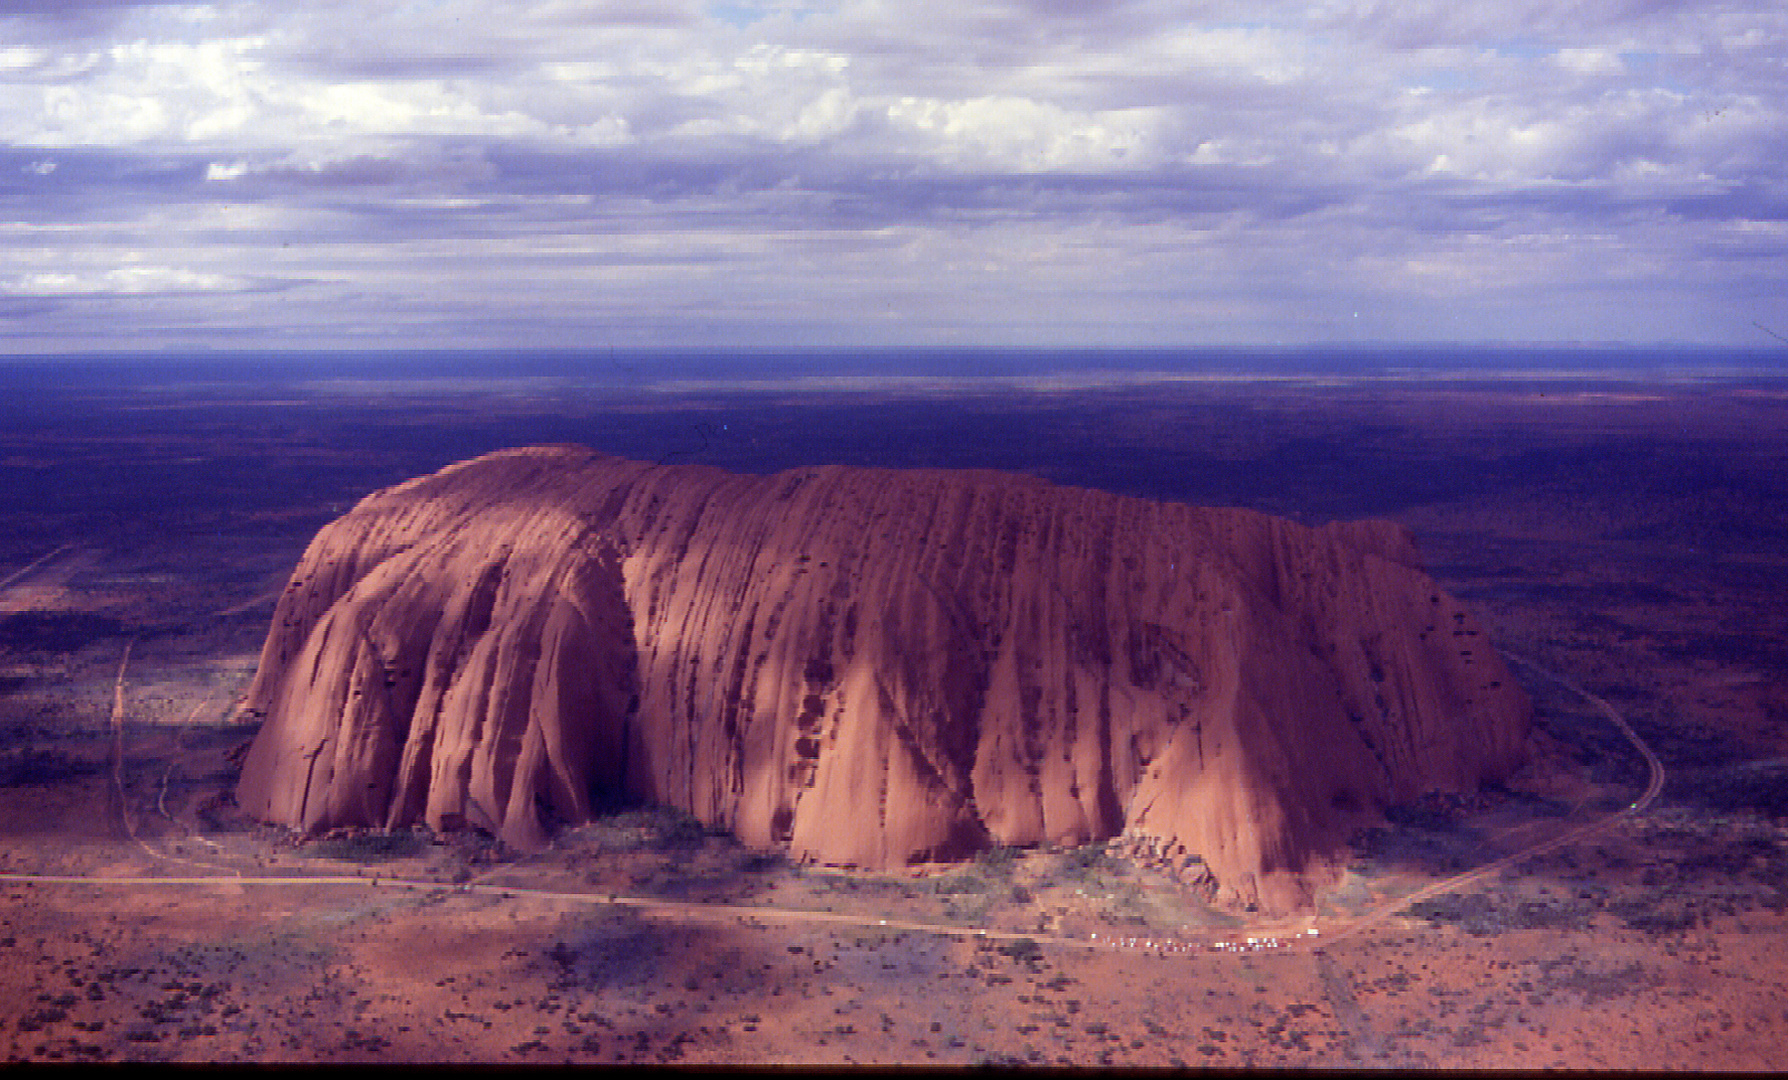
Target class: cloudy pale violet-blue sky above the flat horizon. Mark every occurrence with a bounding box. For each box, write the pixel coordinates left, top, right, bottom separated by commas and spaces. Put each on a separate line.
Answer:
0, 0, 1788, 352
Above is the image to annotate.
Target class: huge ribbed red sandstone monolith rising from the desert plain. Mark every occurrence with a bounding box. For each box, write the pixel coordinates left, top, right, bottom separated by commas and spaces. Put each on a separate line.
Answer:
238, 447, 1531, 908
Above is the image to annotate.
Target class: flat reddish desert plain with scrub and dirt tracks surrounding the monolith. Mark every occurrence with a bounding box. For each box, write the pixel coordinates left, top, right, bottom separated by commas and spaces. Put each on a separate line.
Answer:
0, 368, 1788, 1069
